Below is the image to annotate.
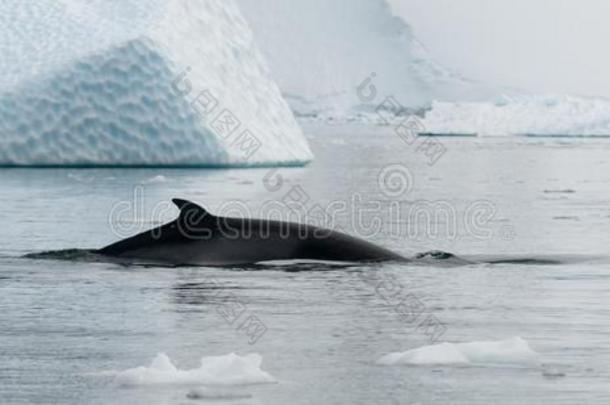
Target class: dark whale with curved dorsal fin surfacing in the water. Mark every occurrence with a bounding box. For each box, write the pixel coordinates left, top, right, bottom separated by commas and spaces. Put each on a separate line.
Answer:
94, 198, 410, 266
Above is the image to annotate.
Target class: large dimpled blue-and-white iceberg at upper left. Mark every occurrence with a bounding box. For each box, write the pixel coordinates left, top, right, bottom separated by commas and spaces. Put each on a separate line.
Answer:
0, 0, 312, 166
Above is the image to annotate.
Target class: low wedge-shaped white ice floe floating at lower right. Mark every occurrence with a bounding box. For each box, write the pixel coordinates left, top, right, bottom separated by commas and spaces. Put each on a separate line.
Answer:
378, 337, 538, 365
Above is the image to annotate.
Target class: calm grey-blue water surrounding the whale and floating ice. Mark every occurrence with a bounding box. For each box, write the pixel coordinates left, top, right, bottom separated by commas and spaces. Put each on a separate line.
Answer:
0, 124, 610, 404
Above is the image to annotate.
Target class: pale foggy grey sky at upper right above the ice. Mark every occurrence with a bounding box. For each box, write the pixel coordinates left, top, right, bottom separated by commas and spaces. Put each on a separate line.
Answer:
389, 0, 610, 97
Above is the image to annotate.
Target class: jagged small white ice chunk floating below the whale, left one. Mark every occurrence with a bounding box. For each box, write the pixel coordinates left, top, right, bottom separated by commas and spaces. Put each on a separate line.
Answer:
115, 353, 276, 386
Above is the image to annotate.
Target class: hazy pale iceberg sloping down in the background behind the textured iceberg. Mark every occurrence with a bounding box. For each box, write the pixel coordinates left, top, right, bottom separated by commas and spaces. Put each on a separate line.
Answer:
238, 0, 487, 119
